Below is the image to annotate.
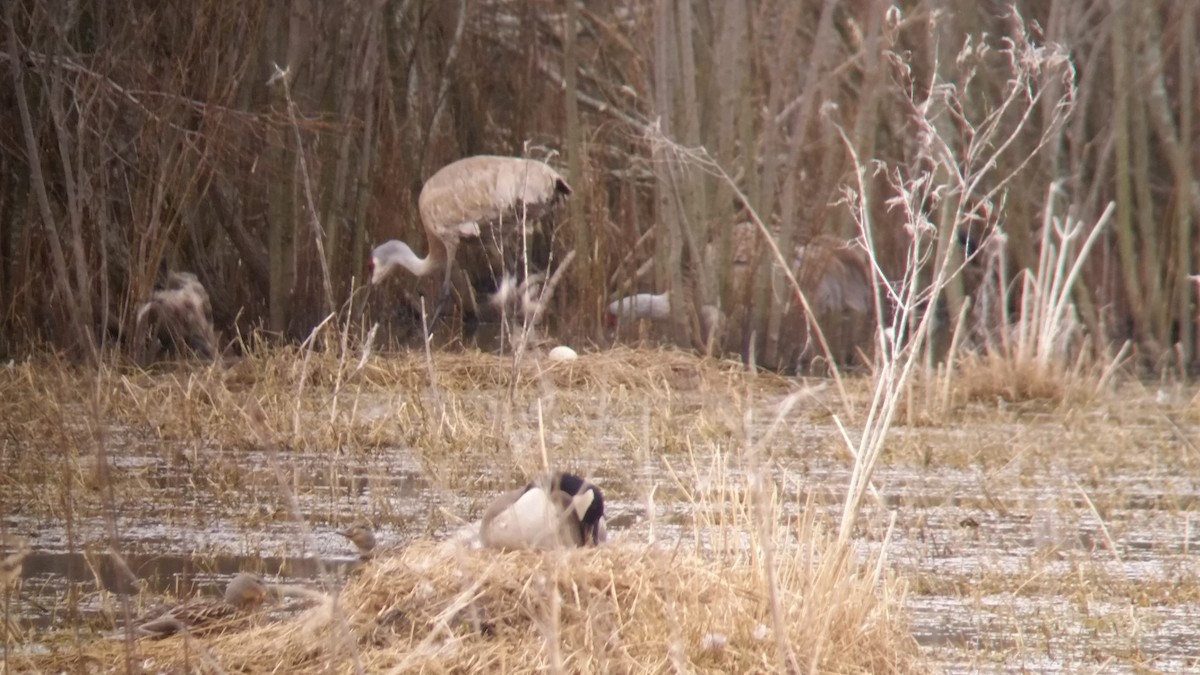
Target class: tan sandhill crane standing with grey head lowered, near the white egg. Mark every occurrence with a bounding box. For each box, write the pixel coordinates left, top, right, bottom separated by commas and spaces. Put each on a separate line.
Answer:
371, 155, 571, 318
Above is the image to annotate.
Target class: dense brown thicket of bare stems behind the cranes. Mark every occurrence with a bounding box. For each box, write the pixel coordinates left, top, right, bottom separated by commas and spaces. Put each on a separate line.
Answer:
0, 0, 1200, 369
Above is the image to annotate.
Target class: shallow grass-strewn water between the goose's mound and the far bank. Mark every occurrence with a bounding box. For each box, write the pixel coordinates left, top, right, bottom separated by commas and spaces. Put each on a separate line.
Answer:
5, 372, 1200, 673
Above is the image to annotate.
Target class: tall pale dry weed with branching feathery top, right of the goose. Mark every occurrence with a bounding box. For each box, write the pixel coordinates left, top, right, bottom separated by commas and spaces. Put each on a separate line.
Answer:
827, 15, 1078, 538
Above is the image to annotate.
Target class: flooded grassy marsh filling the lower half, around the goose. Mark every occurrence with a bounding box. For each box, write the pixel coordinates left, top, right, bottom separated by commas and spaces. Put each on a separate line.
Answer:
0, 351, 1200, 673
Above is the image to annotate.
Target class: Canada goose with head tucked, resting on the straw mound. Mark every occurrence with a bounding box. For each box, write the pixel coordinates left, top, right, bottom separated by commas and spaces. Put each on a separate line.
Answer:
479, 473, 607, 550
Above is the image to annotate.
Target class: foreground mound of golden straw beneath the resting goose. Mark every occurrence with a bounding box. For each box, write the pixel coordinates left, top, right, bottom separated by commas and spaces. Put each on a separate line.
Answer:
26, 542, 916, 673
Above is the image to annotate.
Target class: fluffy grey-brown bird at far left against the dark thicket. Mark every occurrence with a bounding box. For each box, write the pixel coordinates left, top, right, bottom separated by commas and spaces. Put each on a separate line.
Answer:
137, 271, 217, 359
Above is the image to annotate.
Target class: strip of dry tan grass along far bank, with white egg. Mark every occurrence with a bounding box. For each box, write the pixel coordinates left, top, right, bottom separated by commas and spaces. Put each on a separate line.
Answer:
0, 347, 790, 448
